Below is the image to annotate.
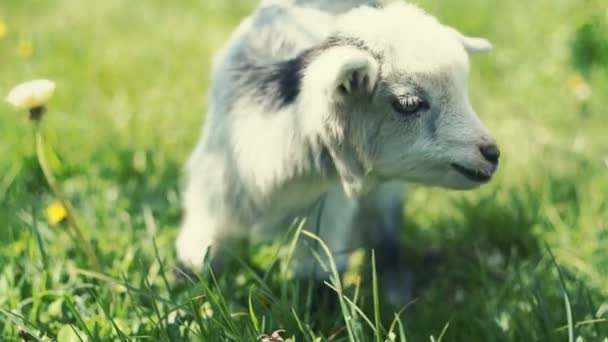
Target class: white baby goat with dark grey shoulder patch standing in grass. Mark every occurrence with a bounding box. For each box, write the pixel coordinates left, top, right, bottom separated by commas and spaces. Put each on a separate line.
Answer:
177, 0, 499, 300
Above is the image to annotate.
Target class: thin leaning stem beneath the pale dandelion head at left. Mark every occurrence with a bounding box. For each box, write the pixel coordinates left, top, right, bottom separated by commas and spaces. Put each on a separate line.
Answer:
35, 121, 103, 273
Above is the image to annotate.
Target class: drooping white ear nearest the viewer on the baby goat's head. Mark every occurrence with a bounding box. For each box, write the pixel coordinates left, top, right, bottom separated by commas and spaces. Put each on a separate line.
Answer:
301, 46, 380, 197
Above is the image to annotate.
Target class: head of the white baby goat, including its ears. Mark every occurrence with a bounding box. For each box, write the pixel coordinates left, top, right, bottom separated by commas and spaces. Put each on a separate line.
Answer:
303, 4, 499, 194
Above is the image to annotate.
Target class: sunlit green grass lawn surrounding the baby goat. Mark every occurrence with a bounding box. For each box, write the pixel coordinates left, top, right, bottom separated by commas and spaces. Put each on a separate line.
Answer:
0, 0, 608, 341
